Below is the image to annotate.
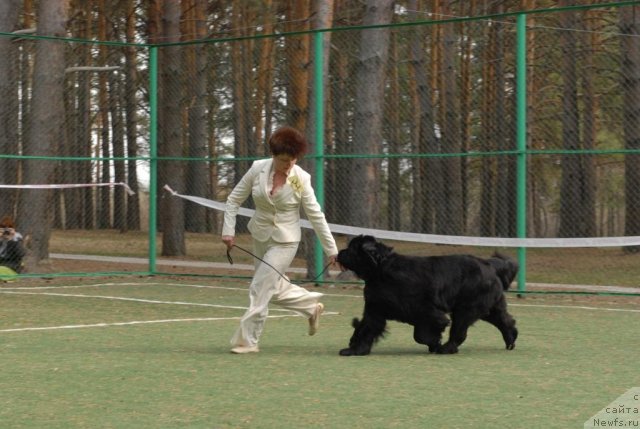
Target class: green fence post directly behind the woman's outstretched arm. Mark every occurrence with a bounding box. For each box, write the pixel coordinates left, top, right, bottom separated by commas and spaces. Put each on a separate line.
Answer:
313, 31, 324, 280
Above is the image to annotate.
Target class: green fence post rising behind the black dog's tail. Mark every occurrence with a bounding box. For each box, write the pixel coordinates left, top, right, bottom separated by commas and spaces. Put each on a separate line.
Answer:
516, 13, 527, 292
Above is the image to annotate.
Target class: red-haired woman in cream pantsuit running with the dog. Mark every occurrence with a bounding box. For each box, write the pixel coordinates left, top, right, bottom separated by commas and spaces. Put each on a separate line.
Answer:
222, 127, 338, 353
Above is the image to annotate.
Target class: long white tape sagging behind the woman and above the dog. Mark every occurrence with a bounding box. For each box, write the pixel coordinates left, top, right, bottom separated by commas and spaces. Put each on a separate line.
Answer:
164, 185, 640, 247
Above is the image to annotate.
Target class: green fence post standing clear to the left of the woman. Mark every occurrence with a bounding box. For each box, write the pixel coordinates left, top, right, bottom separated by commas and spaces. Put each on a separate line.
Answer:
149, 46, 158, 274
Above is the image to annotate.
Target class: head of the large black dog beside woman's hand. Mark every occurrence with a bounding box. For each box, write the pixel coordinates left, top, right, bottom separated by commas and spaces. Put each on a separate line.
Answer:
337, 235, 393, 280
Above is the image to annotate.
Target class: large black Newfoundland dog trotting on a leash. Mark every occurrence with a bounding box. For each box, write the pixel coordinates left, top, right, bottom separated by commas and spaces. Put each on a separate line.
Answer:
338, 235, 518, 356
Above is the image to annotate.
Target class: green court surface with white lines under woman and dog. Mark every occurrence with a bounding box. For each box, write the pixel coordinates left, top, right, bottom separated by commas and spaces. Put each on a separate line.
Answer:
0, 277, 640, 429
